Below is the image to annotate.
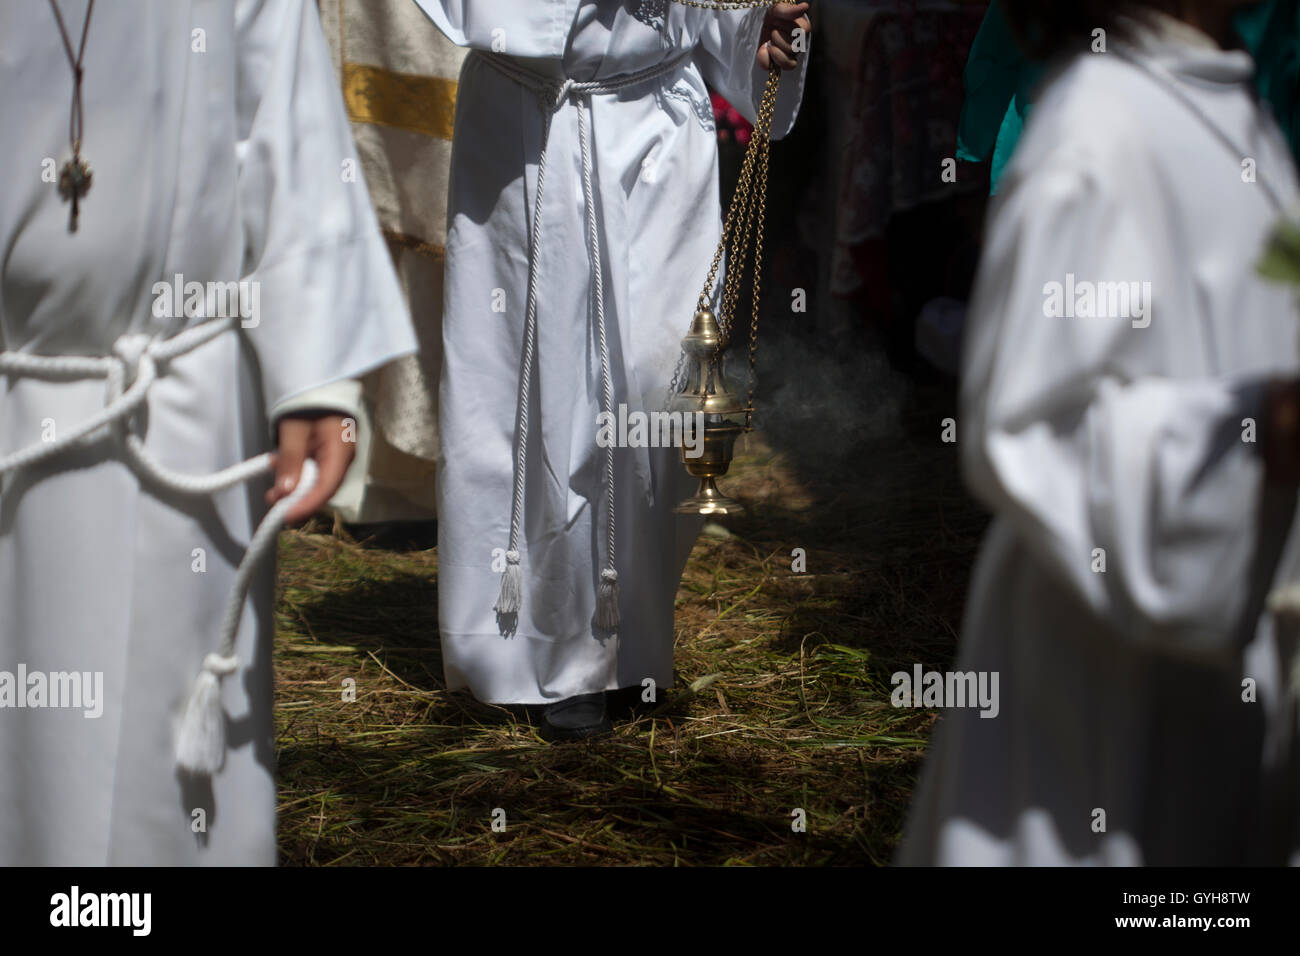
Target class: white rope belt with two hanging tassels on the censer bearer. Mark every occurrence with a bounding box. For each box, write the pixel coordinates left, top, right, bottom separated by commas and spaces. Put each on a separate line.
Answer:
471, 49, 690, 631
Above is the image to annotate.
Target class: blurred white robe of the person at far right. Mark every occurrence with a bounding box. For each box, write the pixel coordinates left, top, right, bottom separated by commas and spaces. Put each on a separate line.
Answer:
900, 14, 1300, 865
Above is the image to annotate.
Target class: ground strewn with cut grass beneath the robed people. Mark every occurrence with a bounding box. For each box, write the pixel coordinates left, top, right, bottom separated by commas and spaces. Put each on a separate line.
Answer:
276, 361, 984, 865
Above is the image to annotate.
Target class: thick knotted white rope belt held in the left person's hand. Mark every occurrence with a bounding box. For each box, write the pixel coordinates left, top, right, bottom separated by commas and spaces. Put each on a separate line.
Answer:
0, 319, 316, 774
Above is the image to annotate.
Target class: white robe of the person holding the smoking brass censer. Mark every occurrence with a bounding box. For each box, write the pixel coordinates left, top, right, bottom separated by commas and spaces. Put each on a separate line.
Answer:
420, 0, 807, 704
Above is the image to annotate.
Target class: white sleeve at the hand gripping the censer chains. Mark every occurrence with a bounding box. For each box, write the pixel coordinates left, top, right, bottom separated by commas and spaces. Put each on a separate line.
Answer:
696, 7, 811, 139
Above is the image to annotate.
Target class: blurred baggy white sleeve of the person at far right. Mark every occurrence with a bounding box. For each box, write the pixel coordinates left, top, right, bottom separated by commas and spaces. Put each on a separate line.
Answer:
958, 157, 1279, 653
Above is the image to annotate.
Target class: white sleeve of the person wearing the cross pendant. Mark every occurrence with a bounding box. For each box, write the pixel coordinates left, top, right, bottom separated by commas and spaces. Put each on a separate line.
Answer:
235, 0, 416, 408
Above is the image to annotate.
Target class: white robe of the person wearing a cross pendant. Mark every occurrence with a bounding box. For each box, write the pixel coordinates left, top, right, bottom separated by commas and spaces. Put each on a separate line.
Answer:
0, 0, 415, 865
